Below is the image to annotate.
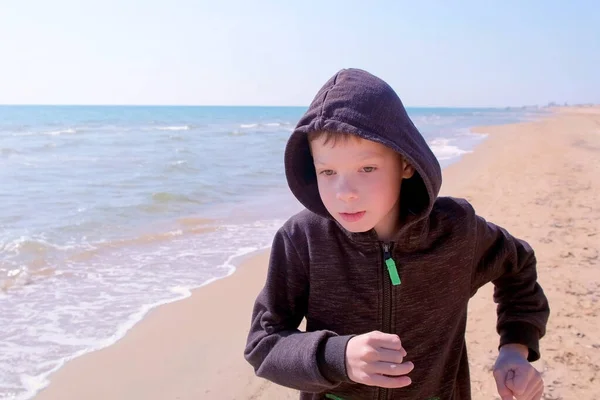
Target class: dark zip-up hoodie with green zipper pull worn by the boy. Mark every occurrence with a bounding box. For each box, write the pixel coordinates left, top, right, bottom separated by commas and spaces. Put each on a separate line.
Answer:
244, 69, 549, 400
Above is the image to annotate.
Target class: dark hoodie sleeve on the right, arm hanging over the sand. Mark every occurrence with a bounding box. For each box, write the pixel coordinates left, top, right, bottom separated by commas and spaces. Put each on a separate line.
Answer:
471, 215, 550, 361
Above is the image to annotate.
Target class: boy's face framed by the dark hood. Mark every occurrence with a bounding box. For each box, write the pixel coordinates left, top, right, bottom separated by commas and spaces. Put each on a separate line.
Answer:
310, 135, 414, 240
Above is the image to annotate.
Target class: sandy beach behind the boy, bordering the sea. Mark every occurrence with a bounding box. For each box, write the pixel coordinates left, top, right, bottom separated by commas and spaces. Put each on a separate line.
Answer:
35, 107, 600, 400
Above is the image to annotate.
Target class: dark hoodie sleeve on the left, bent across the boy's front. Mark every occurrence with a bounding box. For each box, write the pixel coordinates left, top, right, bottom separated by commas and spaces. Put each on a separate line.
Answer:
244, 229, 351, 392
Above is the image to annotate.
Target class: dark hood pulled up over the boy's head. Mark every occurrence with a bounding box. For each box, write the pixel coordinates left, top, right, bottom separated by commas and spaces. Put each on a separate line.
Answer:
284, 69, 442, 239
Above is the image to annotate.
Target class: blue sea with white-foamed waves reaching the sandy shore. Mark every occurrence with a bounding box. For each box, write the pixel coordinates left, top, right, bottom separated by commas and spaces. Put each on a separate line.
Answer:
0, 106, 543, 400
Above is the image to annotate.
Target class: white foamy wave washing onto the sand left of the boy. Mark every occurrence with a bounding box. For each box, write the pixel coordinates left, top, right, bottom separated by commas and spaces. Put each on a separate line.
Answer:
0, 216, 282, 400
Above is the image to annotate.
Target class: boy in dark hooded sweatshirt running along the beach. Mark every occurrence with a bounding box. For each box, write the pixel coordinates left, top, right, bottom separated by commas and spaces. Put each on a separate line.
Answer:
244, 69, 549, 400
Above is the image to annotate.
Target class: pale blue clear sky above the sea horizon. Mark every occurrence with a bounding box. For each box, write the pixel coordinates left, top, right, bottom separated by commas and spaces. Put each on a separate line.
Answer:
0, 0, 600, 106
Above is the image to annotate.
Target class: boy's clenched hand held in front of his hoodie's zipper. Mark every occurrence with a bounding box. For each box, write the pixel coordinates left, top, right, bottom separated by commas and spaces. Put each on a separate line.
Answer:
346, 331, 414, 388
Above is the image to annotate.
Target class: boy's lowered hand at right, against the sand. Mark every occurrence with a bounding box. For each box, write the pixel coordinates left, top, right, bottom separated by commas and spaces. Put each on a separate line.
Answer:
494, 344, 544, 400
